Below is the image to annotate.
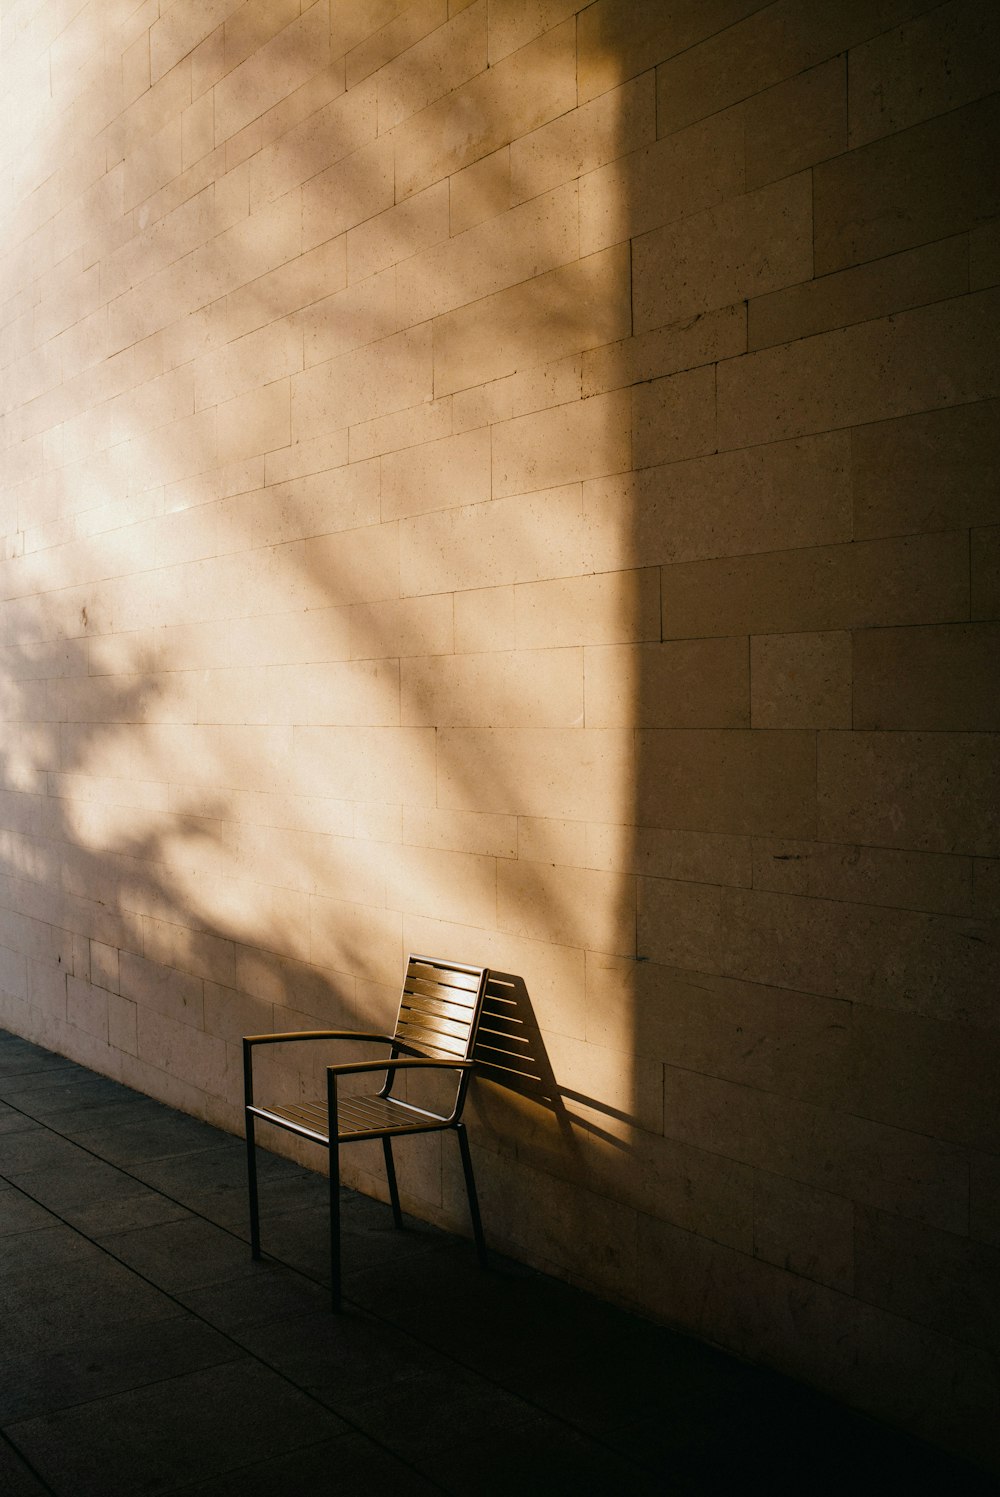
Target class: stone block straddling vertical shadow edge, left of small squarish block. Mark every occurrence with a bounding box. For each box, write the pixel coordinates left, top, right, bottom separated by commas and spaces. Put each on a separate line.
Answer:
584, 639, 745, 728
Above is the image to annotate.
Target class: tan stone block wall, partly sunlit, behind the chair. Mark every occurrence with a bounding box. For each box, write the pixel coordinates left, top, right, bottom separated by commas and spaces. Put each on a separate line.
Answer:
0, 0, 1000, 1461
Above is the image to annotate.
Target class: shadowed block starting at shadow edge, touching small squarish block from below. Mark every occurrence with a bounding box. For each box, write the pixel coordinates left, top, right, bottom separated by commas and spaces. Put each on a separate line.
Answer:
636, 729, 816, 837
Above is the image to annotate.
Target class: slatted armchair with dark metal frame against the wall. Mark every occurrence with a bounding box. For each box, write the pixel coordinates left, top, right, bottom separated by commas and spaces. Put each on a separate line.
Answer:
243, 955, 490, 1310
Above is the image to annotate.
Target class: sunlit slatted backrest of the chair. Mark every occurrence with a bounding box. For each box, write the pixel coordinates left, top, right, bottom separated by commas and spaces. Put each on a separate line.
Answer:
394, 955, 490, 1100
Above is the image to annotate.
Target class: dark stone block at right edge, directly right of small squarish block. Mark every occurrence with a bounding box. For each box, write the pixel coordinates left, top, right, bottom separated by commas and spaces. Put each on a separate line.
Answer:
850, 623, 1000, 732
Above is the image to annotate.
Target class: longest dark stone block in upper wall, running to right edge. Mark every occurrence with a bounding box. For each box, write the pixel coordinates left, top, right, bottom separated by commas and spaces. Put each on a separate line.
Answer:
717, 290, 1000, 448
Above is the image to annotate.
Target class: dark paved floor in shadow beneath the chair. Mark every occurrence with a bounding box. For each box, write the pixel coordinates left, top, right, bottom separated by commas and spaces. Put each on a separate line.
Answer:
0, 1033, 996, 1497
